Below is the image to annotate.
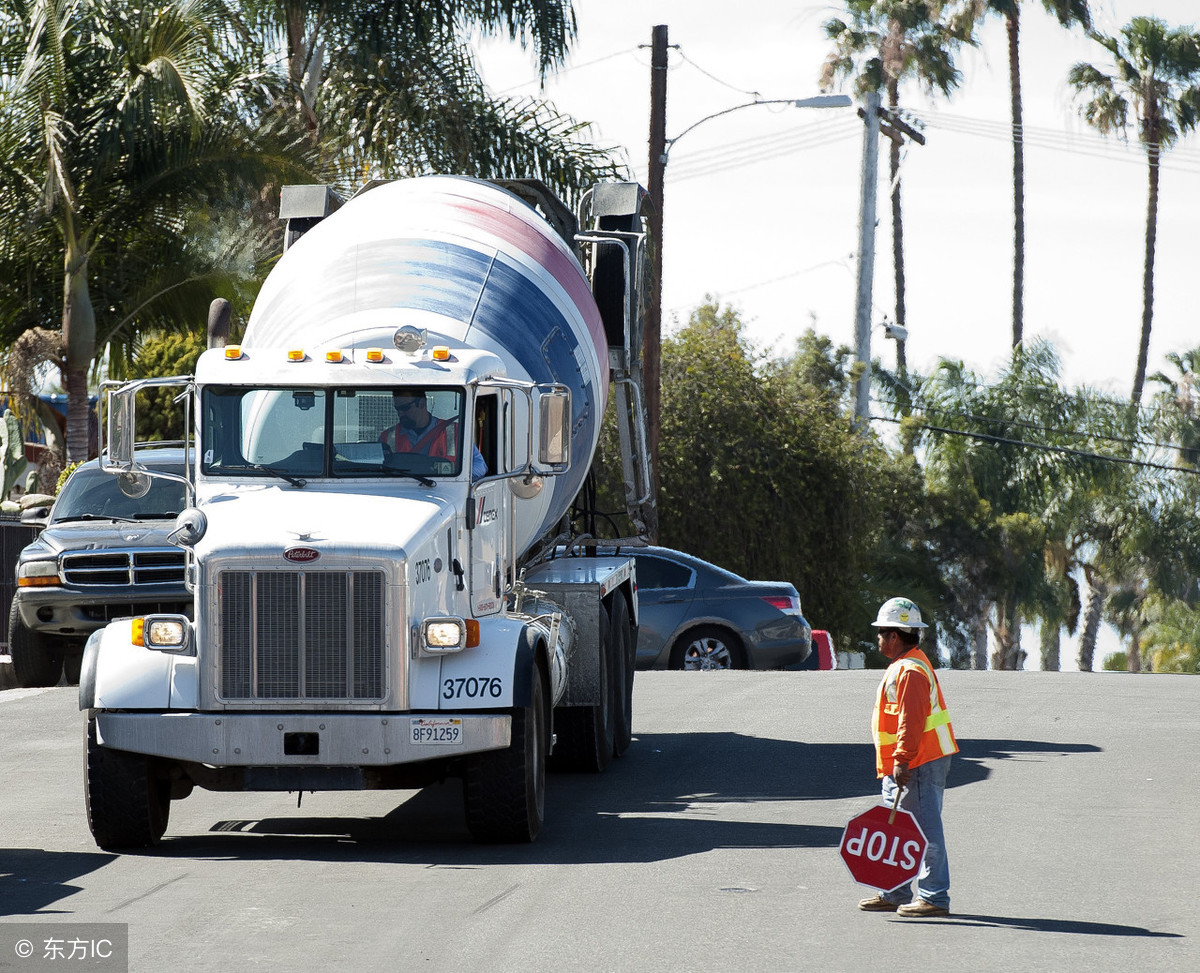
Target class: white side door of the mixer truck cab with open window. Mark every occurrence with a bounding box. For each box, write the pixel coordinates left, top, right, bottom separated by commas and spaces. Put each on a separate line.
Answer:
463, 390, 512, 617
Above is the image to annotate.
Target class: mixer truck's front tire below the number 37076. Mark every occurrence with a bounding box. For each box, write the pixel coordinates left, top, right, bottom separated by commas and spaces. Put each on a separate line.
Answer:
462, 662, 550, 843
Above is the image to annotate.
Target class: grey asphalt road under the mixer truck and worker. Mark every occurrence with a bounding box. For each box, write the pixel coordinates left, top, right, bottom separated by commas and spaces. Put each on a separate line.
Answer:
0, 671, 1200, 973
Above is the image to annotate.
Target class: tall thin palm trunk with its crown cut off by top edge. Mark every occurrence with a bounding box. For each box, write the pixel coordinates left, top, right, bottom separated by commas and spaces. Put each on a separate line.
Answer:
966, 0, 1092, 348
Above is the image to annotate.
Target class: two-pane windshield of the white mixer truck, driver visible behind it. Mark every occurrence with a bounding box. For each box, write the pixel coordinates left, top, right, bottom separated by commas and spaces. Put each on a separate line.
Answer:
200, 386, 466, 486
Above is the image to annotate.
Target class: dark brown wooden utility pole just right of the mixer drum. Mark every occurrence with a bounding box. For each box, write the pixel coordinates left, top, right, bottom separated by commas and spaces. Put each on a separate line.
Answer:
642, 24, 667, 541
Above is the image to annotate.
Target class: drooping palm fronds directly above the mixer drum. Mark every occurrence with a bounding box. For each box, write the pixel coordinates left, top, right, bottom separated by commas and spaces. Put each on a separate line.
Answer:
232, 0, 613, 198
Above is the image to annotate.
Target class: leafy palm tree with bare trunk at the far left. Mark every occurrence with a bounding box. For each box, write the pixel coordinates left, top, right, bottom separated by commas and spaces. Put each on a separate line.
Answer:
0, 0, 311, 462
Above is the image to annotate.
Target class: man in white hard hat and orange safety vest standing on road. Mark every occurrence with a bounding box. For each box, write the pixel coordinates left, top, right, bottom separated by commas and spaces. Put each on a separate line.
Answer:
858, 597, 959, 918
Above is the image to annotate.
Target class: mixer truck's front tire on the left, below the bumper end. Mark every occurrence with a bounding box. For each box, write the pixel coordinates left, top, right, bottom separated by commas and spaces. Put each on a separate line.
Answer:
84, 719, 170, 852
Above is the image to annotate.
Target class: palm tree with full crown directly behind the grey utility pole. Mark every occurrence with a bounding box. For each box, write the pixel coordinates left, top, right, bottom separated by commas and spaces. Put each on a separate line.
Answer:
821, 0, 972, 377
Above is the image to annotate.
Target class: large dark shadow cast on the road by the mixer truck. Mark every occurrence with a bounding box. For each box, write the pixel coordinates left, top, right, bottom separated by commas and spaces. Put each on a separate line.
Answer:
84, 732, 1097, 867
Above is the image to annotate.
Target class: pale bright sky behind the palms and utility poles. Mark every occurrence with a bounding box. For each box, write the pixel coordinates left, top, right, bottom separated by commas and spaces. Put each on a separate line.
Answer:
478, 0, 1200, 397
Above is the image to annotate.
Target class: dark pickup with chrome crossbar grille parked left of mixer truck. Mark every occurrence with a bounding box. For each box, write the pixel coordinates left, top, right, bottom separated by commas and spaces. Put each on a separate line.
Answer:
8, 448, 192, 687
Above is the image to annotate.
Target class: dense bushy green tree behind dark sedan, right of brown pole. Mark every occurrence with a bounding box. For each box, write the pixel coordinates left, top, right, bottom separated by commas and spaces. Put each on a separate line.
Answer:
601, 304, 899, 639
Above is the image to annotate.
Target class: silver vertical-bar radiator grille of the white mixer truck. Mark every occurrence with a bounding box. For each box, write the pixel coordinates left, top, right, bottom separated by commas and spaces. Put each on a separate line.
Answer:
217, 571, 385, 699
